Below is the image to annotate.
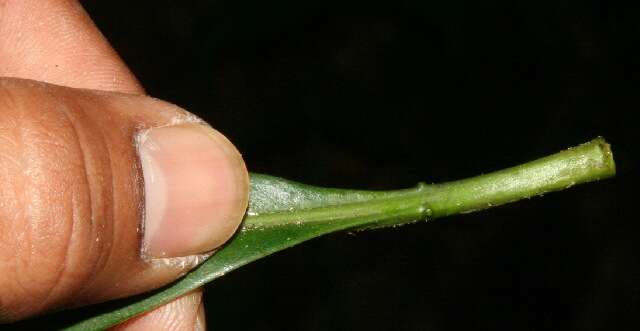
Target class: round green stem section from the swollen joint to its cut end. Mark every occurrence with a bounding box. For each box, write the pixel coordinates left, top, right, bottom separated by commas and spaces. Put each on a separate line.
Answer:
425, 137, 616, 217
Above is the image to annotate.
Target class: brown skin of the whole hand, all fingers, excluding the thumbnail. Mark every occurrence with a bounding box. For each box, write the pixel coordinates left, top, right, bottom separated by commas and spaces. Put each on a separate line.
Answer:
0, 0, 234, 330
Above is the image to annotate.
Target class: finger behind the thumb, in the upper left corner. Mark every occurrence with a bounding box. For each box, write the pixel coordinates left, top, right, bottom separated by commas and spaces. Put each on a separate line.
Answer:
0, 0, 144, 94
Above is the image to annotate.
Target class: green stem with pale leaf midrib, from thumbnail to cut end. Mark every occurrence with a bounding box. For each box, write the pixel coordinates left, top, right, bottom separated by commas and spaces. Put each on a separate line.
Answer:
244, 138, 615, 229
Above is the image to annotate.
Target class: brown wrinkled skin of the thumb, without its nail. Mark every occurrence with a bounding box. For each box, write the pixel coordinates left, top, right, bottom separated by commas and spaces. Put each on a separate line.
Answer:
0, 79, 236, 321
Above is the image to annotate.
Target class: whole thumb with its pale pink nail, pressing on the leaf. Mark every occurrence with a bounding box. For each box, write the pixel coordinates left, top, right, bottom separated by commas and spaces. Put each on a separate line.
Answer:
0, 79, 248, 322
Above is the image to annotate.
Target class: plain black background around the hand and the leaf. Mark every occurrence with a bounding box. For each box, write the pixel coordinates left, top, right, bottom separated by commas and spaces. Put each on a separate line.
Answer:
11, 0, 640, 330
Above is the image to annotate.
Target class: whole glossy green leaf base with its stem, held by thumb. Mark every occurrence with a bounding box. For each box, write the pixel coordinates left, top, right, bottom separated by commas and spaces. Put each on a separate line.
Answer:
61, 138, 615, 330
